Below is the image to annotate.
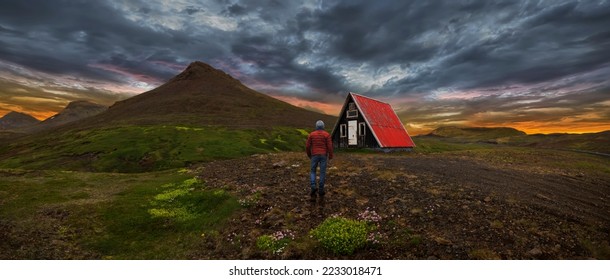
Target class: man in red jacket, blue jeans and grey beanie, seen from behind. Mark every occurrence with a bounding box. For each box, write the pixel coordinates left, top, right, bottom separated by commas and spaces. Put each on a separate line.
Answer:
305, 120, 333, 200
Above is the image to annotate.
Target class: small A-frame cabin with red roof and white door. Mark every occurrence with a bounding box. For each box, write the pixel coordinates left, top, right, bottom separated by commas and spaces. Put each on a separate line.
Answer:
331, 92, 415, 151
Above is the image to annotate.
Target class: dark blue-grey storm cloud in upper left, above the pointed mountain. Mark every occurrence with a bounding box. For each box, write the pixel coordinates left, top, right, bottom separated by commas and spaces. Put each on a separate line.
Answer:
0, 1, 223, 82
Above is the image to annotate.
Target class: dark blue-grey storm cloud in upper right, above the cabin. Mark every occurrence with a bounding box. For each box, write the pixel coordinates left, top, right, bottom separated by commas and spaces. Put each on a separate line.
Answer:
294, 1, 610, 92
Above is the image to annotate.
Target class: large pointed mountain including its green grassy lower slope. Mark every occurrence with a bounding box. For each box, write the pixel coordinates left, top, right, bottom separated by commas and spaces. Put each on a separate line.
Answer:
0, 62, 336, 172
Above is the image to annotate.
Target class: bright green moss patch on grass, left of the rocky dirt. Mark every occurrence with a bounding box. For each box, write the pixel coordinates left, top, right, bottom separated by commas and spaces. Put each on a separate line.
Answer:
89, 178, 241, 259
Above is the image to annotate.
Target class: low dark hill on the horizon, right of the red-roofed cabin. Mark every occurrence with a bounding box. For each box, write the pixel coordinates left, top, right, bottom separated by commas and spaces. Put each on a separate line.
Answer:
428, 126, 526, 141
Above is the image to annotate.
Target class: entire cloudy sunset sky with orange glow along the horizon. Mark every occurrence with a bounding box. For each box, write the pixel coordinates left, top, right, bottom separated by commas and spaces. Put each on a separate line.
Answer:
0, 0, 610, 135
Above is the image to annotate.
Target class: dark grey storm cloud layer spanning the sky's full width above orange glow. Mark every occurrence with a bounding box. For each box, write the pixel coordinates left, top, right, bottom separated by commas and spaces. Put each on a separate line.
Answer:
0, 1, 610, 94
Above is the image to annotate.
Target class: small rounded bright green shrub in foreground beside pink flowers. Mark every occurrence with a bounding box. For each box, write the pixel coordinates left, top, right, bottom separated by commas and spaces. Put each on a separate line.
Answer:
311, 217, 372, 255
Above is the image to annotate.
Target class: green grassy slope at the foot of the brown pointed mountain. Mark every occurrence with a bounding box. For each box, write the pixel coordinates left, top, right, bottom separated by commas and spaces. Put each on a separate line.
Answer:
0, 126, 307, 172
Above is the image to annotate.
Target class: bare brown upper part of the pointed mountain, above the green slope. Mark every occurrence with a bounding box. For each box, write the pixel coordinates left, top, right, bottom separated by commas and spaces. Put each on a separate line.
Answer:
83, 61, 336, 128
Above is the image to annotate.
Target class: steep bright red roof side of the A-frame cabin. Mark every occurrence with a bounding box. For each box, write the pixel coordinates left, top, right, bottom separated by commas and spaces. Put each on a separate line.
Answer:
350, 92, 415, 148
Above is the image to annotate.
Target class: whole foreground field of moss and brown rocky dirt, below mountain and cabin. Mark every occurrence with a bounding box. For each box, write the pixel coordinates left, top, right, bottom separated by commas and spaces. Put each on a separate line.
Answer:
0, 137, 610, 259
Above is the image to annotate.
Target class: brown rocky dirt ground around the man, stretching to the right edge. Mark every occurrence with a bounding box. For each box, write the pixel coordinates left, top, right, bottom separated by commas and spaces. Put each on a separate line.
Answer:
191, 149, 610, 259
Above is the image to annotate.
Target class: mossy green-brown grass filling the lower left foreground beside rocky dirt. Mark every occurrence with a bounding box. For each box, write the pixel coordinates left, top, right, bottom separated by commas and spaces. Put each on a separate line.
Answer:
0, 169, 241, 259
